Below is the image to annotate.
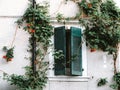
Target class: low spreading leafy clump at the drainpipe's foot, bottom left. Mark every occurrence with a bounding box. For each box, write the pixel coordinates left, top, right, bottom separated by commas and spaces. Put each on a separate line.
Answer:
4, 67, 47, 90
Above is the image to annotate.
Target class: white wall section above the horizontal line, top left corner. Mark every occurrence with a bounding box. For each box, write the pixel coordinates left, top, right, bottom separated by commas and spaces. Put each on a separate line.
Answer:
0, 0, 28, 16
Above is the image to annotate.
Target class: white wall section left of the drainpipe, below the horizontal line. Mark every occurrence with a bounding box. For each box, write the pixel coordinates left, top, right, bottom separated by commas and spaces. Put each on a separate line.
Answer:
0, 18, 29, 90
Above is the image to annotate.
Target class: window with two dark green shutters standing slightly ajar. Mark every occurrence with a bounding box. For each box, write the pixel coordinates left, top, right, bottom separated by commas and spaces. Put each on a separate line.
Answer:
54, 26, 82, 76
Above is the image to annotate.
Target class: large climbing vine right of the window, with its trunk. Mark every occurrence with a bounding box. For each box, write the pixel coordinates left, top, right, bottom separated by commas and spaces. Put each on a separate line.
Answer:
57, 0, 120, 89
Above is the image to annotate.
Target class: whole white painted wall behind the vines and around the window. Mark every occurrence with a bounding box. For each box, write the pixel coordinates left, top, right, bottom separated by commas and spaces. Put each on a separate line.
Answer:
0, 0, 120, 90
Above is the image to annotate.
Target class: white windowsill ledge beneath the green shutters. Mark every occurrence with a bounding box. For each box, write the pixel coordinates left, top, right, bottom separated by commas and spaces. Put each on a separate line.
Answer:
48, 76, 90, 82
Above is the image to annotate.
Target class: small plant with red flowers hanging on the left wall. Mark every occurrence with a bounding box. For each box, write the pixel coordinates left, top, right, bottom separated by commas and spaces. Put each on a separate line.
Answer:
3, 46, 14, 62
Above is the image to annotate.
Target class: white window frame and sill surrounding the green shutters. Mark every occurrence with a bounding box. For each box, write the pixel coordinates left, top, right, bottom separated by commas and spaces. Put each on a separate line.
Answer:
48, 24, 90, 81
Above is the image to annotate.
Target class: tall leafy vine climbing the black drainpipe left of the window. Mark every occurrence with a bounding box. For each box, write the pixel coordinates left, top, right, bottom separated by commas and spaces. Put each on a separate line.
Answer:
4, 2, 53, 90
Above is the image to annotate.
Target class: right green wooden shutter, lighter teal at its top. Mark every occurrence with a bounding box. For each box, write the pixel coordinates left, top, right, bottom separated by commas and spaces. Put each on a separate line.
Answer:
70, 27, 82, 75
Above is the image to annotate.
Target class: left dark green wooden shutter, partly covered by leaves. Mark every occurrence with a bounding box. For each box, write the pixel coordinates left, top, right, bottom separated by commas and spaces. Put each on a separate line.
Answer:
54, 26, 66, 75
